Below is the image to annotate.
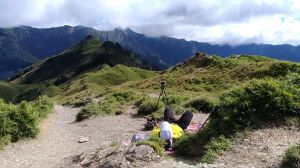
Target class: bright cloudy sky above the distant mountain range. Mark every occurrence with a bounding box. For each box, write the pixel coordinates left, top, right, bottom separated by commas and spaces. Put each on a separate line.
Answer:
0, 0, 300, 45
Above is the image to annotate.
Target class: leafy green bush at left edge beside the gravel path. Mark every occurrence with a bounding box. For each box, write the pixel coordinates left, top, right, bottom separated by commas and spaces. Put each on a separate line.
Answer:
0, 97, 53, 147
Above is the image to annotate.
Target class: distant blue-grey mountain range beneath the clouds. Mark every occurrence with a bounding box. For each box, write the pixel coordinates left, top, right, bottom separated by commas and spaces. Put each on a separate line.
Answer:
0, 26, 300, 79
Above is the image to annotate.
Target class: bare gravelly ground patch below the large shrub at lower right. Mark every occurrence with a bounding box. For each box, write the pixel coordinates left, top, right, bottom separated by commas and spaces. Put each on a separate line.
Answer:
217, 127, 300, 168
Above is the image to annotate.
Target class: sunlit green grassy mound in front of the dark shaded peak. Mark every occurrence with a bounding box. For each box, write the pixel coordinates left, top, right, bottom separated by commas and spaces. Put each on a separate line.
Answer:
56, 65, 157, 104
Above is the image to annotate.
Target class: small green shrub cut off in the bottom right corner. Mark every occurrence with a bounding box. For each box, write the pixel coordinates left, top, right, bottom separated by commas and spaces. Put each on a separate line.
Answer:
281, 143, 300, 168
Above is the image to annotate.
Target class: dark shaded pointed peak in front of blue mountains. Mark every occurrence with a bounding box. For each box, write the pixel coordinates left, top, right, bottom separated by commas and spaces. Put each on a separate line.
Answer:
11, 36, 150, 84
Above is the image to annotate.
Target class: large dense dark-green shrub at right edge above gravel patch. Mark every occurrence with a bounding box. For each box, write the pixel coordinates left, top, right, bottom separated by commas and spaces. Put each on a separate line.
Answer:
219, 79, 300, 132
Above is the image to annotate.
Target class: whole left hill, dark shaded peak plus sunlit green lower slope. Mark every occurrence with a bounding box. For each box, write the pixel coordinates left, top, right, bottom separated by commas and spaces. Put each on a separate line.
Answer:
0, 36, 155, 103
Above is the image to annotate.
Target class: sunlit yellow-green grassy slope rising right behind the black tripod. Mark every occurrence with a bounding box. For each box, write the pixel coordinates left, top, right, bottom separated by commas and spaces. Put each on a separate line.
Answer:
118, 53, 300, 105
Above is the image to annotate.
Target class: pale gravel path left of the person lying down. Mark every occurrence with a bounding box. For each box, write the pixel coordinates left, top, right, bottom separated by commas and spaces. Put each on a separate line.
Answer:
0, 105, 145, 168
